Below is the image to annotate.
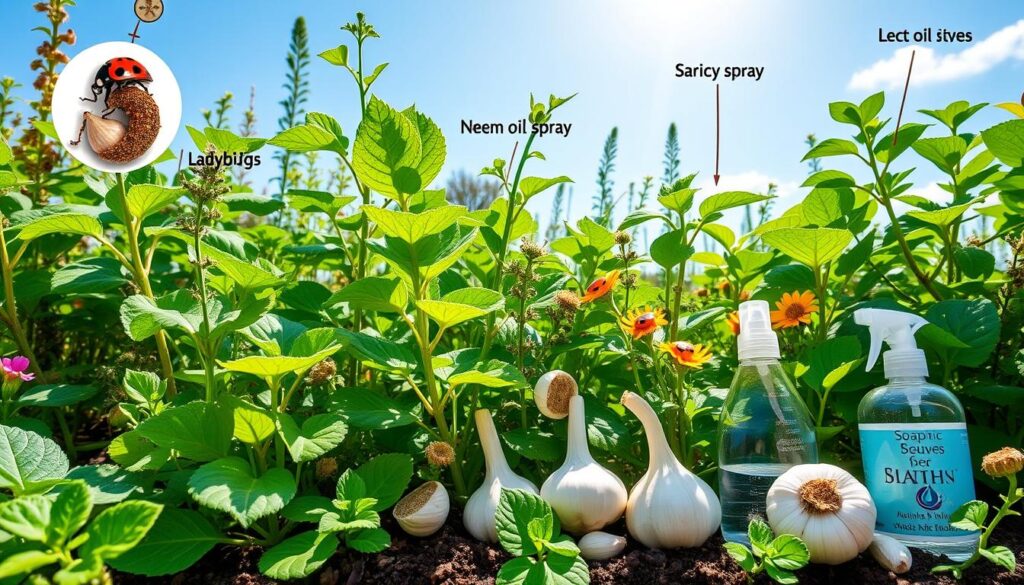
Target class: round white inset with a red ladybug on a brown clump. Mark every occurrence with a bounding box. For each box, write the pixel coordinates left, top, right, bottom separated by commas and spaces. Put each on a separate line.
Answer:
53, 41, 181, 172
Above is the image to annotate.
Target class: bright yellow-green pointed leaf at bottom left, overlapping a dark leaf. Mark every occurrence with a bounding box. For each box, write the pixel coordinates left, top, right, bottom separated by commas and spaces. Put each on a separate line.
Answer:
80, 500, 164, 560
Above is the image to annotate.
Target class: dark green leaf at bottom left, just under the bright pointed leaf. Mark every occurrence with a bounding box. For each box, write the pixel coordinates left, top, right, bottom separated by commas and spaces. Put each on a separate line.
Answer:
109, 507, 224, 577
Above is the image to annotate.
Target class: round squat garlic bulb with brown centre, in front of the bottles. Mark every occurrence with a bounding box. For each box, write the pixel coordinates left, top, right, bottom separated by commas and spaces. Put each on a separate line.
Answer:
765, 463, 876, 565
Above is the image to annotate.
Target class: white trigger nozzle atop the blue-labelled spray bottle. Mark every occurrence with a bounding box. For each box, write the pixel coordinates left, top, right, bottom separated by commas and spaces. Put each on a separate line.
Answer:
853, 308, 928, 379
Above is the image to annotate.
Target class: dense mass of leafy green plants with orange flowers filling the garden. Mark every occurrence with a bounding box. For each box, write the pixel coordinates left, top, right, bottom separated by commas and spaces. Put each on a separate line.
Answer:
0, 0, 1024, 585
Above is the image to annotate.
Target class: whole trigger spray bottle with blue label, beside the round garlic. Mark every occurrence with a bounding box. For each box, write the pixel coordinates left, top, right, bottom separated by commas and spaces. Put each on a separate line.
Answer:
854, 308, 978, 560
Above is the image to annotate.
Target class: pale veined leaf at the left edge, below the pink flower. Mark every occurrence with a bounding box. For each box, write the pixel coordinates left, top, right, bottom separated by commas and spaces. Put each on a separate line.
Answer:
0, 425, 68, 494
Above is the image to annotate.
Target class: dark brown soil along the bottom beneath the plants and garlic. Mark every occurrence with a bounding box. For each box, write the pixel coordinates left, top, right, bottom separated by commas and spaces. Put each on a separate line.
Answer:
116, 510, 1024, 585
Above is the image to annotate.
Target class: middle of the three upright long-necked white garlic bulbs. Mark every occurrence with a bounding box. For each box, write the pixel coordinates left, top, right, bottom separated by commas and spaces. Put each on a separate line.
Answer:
541, 395, 627, 535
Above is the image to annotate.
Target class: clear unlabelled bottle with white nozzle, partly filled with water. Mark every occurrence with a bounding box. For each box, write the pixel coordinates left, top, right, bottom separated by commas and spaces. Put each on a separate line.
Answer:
718, 300, 818, 544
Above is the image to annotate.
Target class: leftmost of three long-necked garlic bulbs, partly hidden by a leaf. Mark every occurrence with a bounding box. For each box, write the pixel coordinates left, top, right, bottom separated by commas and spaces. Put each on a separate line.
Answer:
462, 409, 539, 543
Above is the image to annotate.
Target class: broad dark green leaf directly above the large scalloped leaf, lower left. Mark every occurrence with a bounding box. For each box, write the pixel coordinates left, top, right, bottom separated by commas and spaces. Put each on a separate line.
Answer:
135, 402, 234, 461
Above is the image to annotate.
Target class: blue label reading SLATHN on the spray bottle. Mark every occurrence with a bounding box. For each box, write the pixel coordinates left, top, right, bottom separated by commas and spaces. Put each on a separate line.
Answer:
859, 422, 974, 540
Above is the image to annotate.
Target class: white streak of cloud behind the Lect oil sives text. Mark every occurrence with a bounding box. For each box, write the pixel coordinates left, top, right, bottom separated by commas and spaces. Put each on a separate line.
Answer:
849, 19, 1024, 91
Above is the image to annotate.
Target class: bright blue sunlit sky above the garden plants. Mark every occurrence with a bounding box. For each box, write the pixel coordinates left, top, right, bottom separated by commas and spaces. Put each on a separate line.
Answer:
0, 0, 1024, 233
